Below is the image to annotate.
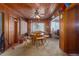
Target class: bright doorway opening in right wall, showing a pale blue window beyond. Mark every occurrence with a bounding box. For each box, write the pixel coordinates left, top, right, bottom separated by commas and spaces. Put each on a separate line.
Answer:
51, 16, 60, 39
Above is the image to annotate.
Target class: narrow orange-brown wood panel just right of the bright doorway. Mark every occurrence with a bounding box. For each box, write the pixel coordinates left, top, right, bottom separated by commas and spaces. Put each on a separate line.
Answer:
60, 12, 67, 51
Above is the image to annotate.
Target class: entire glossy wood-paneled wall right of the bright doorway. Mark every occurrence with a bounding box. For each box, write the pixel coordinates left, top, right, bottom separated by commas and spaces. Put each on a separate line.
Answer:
60, 5, 79, 54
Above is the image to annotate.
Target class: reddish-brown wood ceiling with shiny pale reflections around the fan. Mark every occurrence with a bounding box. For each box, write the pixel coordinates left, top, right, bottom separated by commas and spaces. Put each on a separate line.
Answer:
1, 3, 57, 19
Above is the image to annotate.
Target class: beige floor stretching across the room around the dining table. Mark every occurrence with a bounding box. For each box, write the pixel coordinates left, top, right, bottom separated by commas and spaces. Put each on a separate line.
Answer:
1, 38, 66, 56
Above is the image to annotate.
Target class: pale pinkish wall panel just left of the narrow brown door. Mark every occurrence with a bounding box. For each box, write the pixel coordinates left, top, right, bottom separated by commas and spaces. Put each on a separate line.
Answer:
9, 16, 15, 46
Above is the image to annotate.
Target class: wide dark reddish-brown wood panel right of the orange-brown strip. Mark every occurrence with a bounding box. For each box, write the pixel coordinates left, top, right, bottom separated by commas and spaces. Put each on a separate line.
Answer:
66, 7, 76, 53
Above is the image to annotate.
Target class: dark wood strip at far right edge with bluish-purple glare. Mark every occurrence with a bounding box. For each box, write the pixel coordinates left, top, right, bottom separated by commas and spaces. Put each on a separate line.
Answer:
75, 5, 79, 53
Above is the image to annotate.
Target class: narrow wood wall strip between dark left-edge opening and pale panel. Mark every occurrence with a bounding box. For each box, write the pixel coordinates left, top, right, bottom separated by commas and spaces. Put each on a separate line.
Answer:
4, 13, 9, 49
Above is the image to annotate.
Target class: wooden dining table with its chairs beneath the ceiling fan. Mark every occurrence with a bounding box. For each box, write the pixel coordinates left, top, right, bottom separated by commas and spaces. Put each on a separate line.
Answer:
31, 33, 49, 45
